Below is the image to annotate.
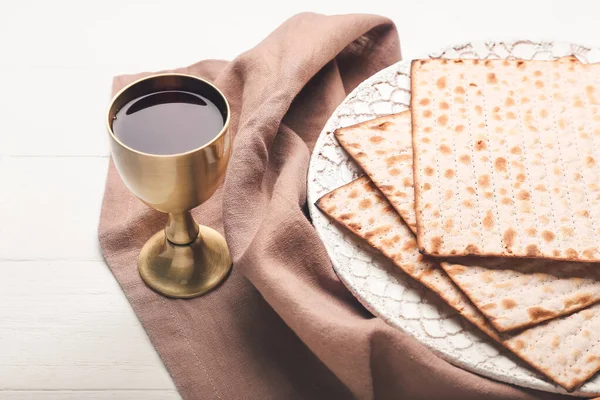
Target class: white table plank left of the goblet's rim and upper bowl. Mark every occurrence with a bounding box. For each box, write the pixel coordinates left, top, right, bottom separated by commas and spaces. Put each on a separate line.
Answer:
0, 68, 112, 157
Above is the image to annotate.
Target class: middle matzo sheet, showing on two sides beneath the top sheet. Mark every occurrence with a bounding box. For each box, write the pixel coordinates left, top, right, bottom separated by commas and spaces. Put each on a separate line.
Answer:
335, 111, 600, 332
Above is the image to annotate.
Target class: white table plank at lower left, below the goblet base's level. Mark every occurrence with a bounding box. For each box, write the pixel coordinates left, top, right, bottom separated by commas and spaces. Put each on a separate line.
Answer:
0, 261, 174, 390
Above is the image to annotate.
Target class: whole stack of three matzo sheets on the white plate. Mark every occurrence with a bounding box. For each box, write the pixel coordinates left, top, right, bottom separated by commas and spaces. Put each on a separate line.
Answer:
317, 59, 600, 390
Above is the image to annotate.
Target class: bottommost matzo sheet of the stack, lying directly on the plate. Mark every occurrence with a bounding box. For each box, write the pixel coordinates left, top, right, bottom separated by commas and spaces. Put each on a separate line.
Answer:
317, 177, 600, 390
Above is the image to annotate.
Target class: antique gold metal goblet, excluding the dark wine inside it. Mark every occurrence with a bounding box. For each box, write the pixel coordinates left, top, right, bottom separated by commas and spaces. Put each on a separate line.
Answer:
107, 74, 231, 298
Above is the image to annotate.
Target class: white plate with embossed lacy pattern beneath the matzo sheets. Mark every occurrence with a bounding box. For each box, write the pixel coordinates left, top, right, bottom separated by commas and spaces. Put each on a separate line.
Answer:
308, 41, 600, 396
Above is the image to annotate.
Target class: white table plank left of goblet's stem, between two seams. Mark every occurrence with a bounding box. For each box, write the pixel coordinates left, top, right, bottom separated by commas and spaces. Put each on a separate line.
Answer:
0, 157, 108, 260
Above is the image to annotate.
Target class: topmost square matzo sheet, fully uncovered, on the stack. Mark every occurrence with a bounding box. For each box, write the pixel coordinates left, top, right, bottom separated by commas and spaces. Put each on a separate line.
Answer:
411, 59, 600, 262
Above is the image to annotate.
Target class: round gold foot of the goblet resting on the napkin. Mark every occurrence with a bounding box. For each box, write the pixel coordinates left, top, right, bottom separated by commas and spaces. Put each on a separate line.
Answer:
138, 225, 231, 298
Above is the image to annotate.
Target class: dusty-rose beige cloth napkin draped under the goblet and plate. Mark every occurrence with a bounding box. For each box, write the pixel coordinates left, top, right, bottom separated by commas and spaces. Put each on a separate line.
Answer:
99, 10, 576, 399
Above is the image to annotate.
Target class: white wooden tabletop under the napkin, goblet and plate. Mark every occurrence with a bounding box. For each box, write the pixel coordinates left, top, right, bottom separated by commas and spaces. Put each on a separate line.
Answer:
0, 0, 600, 400
